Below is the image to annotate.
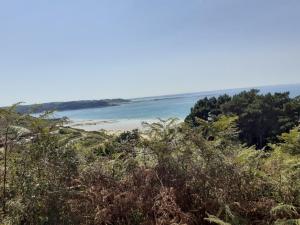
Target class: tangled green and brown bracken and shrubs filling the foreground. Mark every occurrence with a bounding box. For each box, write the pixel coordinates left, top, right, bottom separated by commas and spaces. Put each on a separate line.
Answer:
0, 99, 300, 225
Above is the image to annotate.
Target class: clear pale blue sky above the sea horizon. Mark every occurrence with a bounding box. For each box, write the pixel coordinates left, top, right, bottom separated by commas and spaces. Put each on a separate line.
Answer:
0, 0, 300, 105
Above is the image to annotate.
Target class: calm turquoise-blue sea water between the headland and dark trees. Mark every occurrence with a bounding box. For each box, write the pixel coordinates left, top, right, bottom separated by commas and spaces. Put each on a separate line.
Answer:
56, 84, 300, 120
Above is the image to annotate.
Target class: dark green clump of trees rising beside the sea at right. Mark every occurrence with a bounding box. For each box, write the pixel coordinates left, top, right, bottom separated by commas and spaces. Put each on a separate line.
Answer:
185, 90, 300, 148
